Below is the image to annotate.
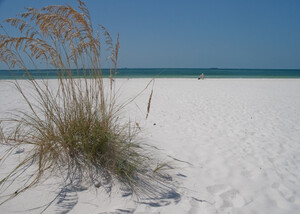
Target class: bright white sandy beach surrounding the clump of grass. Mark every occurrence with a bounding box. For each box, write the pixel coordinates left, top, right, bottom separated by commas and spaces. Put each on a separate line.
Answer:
0, 79, 300, 214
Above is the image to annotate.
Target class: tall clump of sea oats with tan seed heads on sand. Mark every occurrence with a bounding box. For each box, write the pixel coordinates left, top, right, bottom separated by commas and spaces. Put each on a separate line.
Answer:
0, 0, 170, 203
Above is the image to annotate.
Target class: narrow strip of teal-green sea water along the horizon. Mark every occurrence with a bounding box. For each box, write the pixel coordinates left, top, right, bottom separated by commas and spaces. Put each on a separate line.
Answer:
0, 68, 300, 79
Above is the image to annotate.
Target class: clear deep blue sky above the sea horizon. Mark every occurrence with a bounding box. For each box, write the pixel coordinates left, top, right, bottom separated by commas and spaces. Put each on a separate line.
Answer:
0, 0, 300, 69
